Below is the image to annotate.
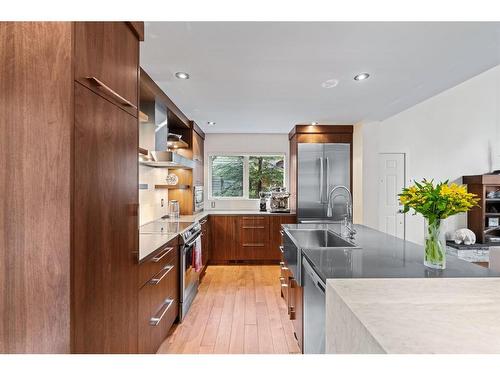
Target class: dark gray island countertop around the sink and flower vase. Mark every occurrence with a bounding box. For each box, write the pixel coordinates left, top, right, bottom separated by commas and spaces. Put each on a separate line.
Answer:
283, 224, 500, 281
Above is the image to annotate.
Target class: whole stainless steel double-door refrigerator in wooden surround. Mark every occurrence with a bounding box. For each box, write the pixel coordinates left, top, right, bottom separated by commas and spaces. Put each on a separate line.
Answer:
297, 143, 351, 222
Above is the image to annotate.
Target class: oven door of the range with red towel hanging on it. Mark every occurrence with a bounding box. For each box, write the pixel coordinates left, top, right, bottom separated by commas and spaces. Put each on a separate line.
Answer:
180, 232, 201, 321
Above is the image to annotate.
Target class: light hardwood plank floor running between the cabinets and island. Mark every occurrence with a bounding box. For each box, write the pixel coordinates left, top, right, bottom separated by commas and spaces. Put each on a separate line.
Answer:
158, 265, 300, 354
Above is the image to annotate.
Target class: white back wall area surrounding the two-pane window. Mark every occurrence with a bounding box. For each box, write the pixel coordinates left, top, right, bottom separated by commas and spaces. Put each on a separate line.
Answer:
204, 133, 289, 210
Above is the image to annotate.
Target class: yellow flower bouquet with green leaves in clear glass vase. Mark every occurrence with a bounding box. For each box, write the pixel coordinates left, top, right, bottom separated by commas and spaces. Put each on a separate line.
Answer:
399, 179, 479, 269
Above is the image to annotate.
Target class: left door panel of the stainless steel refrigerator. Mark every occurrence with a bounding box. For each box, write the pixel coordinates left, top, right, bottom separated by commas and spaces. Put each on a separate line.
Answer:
297, 143, 326, 220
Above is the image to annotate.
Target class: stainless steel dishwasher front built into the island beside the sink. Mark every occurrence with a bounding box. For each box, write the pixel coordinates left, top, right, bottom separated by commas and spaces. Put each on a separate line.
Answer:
302, 257, 325, 354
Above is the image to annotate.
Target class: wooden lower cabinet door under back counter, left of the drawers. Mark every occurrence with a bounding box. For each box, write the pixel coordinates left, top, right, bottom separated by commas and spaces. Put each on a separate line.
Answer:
210, 215, 239, 263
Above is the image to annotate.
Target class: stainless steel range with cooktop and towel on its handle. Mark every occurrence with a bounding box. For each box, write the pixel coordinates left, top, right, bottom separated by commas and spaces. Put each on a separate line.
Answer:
179, 222, 201, 322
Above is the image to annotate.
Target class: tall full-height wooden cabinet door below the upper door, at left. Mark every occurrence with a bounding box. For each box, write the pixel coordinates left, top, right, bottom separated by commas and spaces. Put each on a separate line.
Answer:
72, 83, 139, 353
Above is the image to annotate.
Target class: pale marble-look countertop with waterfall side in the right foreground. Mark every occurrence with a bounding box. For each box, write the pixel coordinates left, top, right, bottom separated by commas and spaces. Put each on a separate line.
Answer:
325, 278, 500, 354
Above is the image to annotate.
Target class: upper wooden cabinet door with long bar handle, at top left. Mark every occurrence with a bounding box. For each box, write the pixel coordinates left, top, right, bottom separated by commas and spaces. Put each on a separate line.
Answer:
74, 22, 139, 117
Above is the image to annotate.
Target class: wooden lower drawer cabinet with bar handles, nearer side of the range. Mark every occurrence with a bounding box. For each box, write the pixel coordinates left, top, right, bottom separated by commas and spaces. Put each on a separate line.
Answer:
138, 239, 180, 353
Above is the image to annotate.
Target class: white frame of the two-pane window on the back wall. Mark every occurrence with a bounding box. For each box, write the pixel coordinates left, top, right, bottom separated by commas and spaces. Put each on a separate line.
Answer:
207, 152, 288, 201
